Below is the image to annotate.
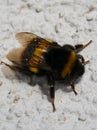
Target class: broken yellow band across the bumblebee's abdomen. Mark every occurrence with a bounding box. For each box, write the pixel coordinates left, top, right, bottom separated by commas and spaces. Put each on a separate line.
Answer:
29, 41, 51, 73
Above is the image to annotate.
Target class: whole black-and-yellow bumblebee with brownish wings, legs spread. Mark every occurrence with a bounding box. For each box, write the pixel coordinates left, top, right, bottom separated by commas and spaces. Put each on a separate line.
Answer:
2, 32, 92, 111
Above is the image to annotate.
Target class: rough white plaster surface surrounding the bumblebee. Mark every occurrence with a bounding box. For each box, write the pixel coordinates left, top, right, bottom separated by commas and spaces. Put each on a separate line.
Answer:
0, 0, 97, 130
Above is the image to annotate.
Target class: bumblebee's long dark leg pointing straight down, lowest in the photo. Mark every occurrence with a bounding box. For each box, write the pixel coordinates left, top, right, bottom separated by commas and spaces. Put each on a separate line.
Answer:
48, 74, 56, 112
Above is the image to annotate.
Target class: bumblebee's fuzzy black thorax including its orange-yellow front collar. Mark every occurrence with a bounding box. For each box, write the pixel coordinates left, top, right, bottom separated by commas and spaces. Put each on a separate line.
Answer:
46, 47, 76, 79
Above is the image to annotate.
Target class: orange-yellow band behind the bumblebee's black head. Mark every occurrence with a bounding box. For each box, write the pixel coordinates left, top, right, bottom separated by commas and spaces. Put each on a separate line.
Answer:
61, 51, 76, 78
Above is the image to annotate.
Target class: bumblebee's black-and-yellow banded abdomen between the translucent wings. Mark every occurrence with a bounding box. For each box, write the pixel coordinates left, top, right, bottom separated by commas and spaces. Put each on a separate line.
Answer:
22, 38, 53, 73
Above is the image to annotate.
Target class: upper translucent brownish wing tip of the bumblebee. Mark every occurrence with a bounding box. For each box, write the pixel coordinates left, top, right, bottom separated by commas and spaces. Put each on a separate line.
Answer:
16, 32, 39, 46
